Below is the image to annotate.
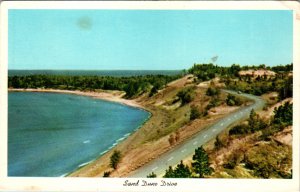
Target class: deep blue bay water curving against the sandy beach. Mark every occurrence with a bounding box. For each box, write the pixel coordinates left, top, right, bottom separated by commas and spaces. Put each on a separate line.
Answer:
8, 92, 150, 176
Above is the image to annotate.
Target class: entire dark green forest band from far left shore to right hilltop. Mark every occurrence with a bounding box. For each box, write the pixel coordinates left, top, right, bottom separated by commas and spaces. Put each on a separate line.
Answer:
8, 63, 293, 100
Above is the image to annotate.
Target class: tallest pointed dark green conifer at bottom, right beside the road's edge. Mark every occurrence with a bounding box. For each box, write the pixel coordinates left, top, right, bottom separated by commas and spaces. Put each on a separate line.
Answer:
192, 146, 213, 178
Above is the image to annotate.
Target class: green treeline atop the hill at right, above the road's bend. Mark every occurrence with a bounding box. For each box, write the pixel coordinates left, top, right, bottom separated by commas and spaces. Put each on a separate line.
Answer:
188, 64, 293, 100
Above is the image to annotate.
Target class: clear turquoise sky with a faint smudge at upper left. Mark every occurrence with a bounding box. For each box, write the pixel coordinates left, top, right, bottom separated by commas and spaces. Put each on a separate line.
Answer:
8, 10, 293, 70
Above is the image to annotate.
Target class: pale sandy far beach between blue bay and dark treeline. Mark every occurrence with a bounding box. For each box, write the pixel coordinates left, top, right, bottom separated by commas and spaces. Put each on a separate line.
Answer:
8, 88, 148, 111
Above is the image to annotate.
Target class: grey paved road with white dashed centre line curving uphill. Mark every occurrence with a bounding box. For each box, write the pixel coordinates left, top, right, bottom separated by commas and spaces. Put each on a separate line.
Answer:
129, 90, 265, 178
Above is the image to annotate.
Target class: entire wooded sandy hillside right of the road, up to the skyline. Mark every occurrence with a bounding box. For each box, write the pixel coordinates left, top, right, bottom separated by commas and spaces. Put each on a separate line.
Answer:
168, 65, 293, 178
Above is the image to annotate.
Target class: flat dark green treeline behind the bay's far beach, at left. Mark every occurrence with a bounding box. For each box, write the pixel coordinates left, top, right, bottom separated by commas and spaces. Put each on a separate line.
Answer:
8, 75, 181, 98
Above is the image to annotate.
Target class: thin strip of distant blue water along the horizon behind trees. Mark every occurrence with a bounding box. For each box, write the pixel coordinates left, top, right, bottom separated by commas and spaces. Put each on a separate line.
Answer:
8, 70, 182, 77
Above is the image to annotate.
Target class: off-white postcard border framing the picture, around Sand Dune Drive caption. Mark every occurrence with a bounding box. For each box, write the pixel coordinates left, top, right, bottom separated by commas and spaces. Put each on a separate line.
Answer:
0, 1, 300, 192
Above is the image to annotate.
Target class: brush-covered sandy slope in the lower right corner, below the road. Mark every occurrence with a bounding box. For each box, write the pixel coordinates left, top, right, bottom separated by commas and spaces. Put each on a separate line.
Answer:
200, 95, 293, 178
